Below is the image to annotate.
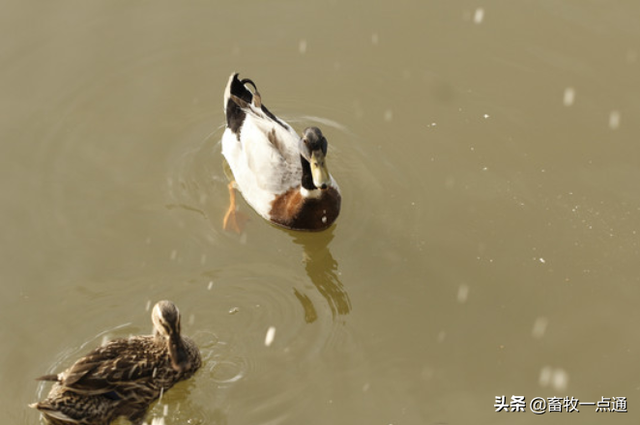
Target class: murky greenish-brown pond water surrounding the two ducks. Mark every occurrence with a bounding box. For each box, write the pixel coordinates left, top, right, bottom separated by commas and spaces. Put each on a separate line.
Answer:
0, 0, 640, 425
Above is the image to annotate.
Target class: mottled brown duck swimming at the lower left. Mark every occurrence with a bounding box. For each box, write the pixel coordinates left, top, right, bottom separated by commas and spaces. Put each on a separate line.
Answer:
30, 301, 202, 425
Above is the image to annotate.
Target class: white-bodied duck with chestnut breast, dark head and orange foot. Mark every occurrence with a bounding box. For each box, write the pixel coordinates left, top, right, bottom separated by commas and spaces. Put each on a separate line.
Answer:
222, 73, 342, 232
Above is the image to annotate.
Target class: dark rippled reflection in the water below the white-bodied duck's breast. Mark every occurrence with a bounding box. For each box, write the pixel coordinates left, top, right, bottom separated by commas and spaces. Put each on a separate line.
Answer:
288, 227, 351, 323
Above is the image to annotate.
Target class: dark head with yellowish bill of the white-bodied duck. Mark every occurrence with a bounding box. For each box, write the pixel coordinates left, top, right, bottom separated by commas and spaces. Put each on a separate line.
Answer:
300, 127, 331, 190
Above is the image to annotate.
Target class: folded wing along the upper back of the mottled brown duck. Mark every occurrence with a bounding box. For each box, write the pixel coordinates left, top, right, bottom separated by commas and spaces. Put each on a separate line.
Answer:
43, 337, 166, 395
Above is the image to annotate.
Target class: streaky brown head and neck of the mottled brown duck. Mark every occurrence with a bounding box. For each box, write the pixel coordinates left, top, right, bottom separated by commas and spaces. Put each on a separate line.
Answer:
151, 300, 190, 372
